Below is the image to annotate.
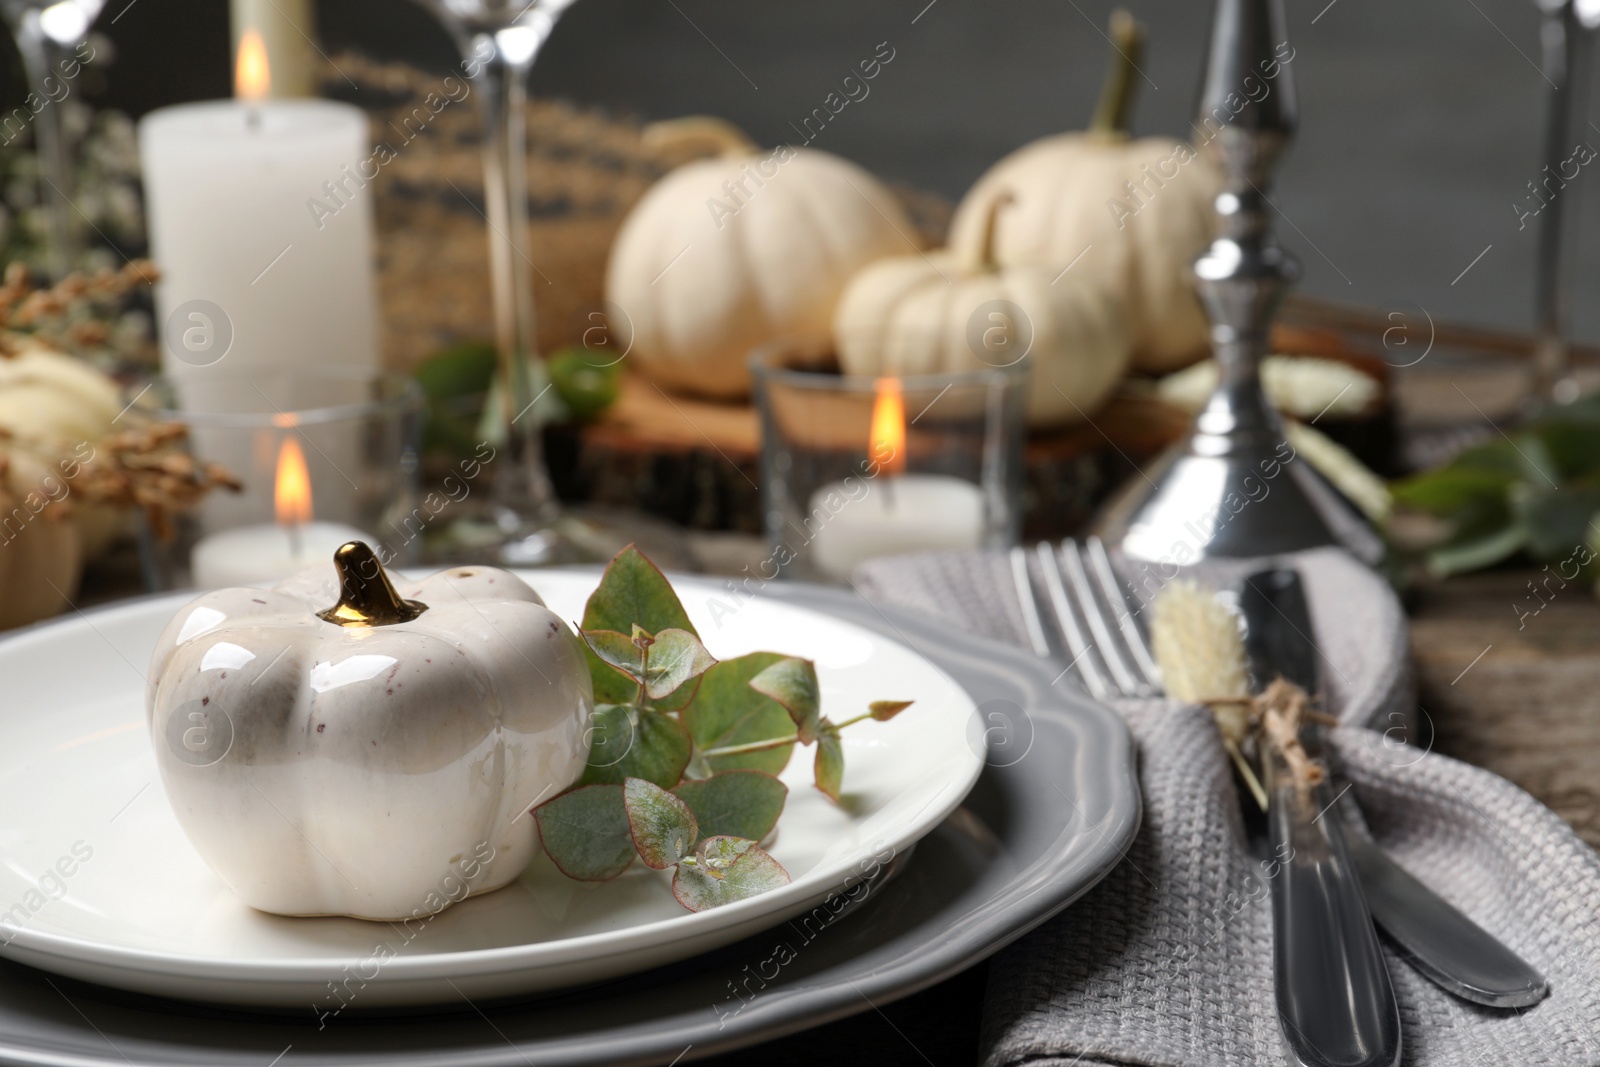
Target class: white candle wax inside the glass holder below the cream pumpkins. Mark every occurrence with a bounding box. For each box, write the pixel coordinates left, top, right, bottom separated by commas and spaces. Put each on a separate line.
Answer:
806, 474, 984, 577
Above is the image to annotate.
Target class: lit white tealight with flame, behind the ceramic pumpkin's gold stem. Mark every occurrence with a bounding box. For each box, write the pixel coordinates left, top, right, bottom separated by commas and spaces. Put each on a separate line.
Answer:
189, 437, 373, 589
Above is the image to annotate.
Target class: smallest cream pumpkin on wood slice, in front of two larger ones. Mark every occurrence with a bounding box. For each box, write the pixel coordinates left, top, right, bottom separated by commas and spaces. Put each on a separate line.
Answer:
834, 195, 1128, 426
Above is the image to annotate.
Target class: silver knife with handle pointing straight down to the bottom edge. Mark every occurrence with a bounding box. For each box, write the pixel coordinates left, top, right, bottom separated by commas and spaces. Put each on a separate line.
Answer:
1238, 569, 1400, 1067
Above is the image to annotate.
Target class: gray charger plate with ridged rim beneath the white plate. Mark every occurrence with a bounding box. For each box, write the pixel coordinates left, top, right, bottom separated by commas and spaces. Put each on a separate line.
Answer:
0, 585, 1139, 1067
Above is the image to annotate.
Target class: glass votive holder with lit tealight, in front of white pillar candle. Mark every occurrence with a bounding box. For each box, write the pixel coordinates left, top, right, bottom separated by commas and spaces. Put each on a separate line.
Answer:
133, 366, 422, 589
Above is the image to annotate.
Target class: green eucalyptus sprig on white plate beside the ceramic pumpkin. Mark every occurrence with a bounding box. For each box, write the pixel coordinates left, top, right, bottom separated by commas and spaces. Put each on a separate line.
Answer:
533, 545, 910, 912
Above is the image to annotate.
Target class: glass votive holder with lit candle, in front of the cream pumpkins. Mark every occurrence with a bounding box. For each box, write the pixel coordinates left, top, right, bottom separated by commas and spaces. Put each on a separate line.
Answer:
750, 341, 1027, 581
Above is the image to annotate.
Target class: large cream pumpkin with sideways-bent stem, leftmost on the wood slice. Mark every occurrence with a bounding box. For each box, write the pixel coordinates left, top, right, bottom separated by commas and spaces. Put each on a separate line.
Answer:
606, 120, 917, 398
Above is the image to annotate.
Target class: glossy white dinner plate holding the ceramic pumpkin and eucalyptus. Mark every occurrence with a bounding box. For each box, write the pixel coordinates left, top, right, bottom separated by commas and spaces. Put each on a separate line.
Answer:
0, 571, 984, 1013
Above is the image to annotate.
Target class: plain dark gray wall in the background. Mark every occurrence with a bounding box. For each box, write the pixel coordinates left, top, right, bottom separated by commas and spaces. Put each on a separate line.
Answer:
15, 0, 1600, 339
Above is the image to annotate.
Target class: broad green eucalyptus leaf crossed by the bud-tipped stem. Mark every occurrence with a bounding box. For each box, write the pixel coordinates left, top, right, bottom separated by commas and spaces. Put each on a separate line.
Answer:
683, 653, 795, 774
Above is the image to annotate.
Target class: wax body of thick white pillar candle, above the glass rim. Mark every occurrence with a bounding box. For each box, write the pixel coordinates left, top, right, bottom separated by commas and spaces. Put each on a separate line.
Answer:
139, 101, 378, 390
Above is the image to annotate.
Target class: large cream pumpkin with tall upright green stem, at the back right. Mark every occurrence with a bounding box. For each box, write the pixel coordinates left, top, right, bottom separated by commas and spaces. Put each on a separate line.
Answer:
950, 11, 1222, 373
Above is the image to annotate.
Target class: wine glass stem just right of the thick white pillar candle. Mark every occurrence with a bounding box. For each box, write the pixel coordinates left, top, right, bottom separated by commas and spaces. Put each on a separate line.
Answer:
475, 38, 558, 525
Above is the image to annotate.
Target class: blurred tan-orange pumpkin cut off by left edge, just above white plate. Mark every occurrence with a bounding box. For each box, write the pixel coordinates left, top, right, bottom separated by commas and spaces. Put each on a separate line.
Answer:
0, 438, 83, 630
